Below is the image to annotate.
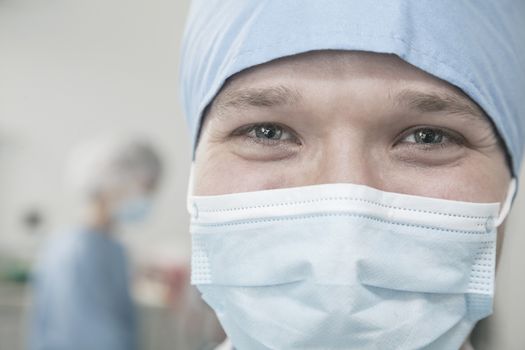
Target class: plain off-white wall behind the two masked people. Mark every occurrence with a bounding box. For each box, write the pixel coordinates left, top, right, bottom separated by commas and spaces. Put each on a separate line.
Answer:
0, 0, 525, 350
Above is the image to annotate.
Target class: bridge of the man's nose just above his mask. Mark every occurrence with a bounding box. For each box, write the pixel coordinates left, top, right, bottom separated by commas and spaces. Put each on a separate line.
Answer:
316, 134, 380, 188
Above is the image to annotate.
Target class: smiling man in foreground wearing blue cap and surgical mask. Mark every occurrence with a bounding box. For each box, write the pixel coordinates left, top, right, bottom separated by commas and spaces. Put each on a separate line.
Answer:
181, 0, 525, 350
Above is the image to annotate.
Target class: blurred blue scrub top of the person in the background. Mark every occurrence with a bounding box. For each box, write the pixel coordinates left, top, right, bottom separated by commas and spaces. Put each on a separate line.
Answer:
29, 230, 136, 350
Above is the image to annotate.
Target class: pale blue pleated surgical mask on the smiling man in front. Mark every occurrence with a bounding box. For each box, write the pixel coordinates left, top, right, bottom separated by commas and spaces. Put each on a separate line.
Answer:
188, 181, 515, 350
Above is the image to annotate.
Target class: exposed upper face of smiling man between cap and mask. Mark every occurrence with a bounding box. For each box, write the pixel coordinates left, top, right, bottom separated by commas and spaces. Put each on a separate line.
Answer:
194, 51, 510, 208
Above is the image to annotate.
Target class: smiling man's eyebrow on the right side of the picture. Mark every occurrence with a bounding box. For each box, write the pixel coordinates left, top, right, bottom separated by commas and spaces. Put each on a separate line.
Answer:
392, 89, 487, 121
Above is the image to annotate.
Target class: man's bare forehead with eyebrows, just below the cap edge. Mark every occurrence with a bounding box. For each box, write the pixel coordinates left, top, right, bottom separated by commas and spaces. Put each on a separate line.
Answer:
212, 50, 487, 122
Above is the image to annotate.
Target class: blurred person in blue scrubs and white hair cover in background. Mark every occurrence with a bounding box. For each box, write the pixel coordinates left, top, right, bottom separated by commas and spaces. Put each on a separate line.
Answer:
29, 138, 162, 350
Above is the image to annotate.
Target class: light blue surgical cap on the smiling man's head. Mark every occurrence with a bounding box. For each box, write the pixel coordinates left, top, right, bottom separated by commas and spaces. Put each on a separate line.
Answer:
181, 0, 525, 175
